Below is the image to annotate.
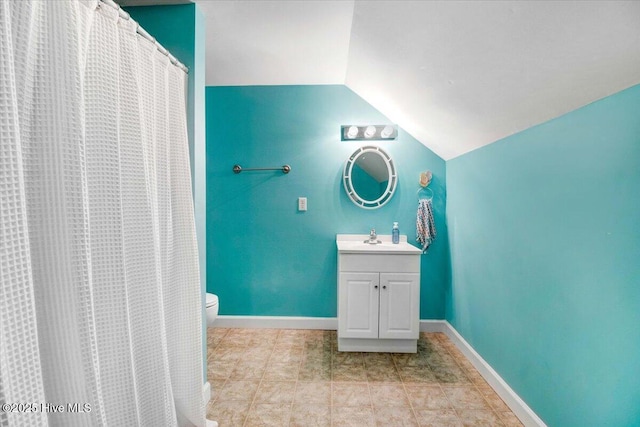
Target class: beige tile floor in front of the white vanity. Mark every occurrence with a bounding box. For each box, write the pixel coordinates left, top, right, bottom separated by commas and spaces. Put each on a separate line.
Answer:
207, 328, 522, 427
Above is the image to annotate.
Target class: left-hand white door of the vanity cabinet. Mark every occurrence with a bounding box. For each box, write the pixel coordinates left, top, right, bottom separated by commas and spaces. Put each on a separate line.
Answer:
338, 273, 380, 338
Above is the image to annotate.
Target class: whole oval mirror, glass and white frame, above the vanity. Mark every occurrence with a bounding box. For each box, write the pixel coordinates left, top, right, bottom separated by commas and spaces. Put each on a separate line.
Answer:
342, 146, 398, 209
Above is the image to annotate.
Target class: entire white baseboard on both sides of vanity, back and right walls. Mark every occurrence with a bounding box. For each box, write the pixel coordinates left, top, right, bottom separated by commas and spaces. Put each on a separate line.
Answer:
209, 315, 546, 427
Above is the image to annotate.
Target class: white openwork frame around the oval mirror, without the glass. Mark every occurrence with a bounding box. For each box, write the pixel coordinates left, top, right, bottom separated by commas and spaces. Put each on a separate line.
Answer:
342, 145, 398, 209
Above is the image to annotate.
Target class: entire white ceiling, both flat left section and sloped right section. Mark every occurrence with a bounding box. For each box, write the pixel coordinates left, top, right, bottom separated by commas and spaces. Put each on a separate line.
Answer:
196, 0, 640, 159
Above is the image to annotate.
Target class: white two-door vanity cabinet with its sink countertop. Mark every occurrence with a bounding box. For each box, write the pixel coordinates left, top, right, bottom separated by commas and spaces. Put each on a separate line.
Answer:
337, 235, 421, 353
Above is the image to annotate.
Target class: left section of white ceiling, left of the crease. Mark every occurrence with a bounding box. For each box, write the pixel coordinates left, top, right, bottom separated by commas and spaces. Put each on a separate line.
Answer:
197, 1, 353, 86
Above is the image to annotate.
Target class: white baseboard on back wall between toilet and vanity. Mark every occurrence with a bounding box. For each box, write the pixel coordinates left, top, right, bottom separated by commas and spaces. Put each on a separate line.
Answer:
213, 315, 338, 331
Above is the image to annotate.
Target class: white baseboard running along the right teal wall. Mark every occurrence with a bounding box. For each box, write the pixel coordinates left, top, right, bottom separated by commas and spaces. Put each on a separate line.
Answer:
437, 320, 546, 427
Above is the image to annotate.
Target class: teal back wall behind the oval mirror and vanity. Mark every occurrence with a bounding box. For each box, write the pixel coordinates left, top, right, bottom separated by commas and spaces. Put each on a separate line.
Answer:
206, 86, 449, 319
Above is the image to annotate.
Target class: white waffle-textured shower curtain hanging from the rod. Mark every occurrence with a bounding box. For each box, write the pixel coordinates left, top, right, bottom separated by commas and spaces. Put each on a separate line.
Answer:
0, 0, 205, 427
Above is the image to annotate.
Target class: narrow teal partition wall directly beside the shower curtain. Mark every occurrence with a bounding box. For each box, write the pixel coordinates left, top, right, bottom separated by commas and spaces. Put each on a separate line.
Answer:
126, 4, 207, 378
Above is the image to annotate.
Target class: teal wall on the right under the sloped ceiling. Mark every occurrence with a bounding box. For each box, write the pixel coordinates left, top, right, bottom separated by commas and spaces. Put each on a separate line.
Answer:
447, 86, 640, 426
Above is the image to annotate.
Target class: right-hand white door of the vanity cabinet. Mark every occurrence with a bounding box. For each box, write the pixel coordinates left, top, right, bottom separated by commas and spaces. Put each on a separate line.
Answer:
379, 273, 420, 339
